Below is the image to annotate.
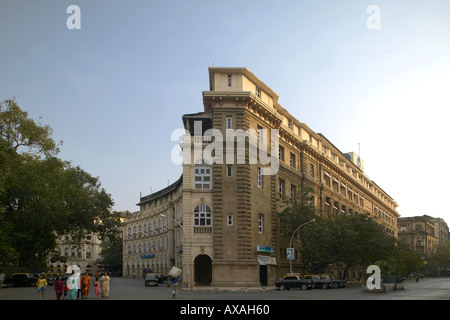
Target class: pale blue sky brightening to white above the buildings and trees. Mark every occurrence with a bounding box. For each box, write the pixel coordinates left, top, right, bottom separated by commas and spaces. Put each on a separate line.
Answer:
0, 0, 450, 223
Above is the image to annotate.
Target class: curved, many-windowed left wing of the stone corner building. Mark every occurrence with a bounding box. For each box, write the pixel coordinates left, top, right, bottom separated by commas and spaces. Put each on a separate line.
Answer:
122, 177, 183, 278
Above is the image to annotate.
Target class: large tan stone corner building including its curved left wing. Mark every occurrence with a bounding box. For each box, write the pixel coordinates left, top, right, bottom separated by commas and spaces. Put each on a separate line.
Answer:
124, 67, 399, 286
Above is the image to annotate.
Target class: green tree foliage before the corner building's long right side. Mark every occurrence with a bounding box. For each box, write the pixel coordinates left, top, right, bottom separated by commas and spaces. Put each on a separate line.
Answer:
280, 190, 421, 274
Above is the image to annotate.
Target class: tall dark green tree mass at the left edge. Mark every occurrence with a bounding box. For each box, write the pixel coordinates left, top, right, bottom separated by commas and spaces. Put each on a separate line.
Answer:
0, 100, 120, 267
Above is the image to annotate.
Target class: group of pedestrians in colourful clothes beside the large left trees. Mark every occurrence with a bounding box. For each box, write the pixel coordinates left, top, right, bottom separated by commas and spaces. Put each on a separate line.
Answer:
36, 271, 111, 300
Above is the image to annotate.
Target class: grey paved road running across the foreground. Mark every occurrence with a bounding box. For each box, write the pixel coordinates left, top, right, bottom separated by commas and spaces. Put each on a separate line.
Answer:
0, 278, 450, 301
